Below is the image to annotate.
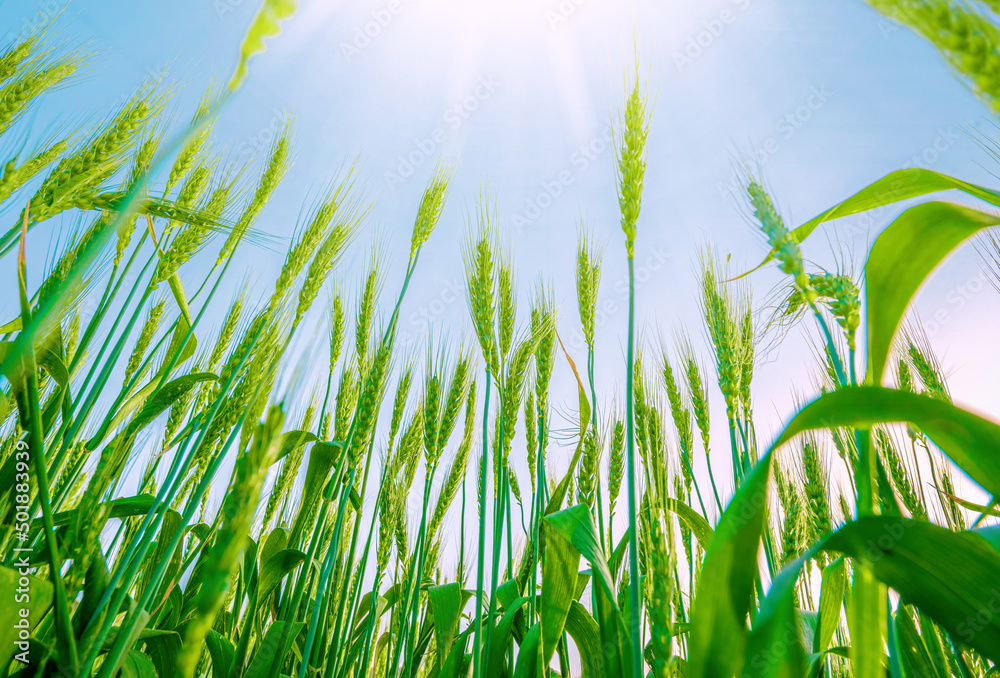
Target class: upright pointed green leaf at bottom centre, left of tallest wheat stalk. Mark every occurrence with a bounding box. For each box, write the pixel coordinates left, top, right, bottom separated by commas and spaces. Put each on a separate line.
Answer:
539, 522, 580, 664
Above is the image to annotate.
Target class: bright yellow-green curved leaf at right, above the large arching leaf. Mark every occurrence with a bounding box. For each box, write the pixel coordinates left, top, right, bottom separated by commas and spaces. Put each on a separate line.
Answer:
865, 202, 1000, 385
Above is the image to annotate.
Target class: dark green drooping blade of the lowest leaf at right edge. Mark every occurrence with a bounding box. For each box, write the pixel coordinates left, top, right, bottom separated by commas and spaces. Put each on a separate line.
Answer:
822, 516, 1000, 662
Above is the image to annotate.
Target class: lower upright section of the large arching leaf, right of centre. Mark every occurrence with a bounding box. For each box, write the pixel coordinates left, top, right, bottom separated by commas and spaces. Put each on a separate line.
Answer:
687, 452, 780, 678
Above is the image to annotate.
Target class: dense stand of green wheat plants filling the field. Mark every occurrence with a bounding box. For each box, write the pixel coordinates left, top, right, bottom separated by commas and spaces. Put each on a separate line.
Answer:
0, 0, 1000, 678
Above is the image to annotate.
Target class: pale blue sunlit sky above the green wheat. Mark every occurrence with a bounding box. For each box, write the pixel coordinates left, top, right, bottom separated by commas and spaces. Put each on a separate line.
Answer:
0, 0, 1000, 516
